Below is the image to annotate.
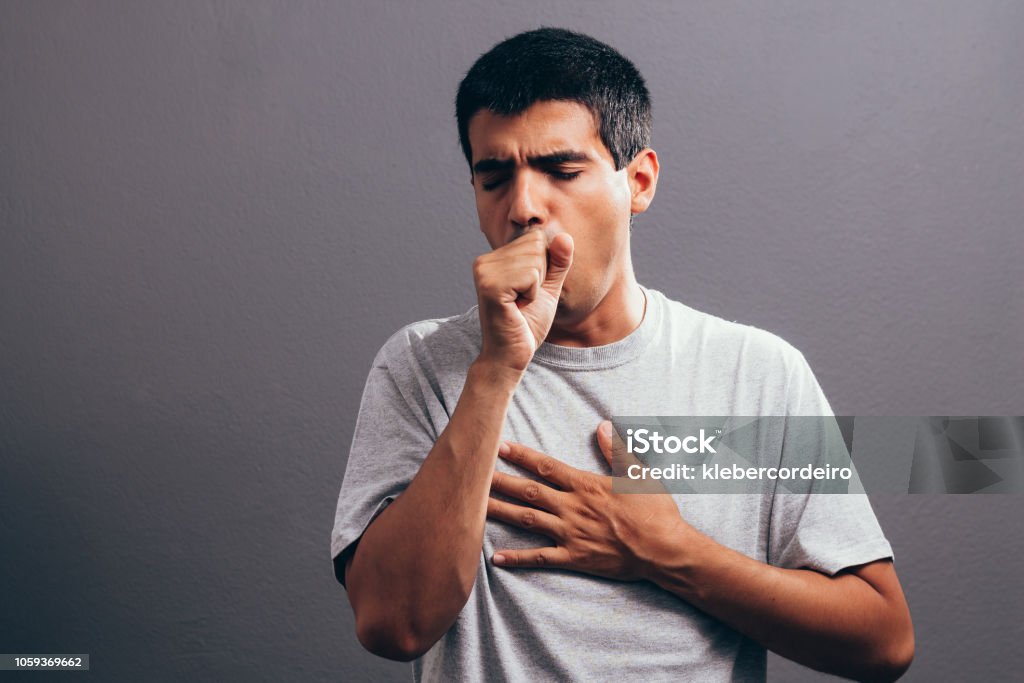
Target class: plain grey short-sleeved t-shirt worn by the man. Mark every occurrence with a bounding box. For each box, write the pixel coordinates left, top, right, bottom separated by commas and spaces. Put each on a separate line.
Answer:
331, 290, 892, 682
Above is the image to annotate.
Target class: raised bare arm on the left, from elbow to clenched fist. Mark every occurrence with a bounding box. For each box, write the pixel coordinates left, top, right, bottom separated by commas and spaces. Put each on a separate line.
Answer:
343, 231, 572, 660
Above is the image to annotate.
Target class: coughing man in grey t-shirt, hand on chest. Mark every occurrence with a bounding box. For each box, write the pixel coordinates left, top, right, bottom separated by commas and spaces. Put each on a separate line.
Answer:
332, 29, 913, 681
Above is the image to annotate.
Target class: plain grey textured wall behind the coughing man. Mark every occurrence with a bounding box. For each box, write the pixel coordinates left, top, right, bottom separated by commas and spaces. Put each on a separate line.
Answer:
0, 0, 1024, 681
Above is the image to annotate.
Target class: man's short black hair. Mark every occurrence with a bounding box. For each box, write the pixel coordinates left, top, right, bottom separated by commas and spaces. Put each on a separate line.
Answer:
455, 28, 651, 171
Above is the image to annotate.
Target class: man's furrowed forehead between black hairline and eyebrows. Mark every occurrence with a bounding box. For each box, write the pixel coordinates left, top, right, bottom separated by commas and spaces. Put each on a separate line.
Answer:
469, 100, 611, 163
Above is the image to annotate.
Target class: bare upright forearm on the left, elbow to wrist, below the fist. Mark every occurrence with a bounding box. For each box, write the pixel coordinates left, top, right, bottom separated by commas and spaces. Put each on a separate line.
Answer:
345, 361, 518, 659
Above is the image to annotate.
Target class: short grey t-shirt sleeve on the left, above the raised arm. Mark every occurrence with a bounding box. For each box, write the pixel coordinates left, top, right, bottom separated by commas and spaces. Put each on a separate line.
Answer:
331, 339, 437, 583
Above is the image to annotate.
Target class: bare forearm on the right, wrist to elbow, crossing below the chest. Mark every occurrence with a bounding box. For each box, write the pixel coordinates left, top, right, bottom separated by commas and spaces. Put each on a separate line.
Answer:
649, 527, 913, 680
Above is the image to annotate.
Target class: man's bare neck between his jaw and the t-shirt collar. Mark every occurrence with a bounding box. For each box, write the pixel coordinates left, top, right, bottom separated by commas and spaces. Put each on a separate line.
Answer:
545, 272, 647, 347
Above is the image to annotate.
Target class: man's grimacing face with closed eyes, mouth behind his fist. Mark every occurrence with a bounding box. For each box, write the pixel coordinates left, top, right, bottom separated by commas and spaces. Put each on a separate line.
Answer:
469, 101, 632, 319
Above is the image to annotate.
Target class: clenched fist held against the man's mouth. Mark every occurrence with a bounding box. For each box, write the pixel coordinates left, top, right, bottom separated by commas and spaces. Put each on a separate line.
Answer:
473, 229, 572, 372
